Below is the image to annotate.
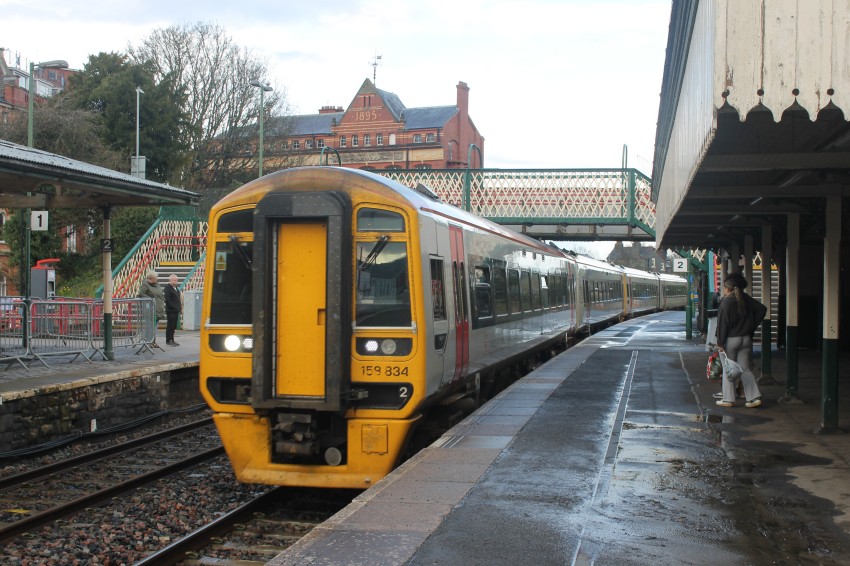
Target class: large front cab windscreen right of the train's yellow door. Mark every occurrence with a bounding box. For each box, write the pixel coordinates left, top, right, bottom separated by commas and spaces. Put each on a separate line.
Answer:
354, 238, 411, 327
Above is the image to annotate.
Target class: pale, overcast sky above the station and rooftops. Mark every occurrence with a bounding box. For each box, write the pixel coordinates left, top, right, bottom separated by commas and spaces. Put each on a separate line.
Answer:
0, 0, 671, 258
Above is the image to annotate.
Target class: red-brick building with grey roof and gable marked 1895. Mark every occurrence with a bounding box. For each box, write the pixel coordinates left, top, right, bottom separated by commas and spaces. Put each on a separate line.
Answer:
264, 79, 484, 170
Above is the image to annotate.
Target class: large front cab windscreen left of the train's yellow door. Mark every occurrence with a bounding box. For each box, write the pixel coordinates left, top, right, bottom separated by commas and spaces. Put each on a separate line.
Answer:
210, 242, 254, 324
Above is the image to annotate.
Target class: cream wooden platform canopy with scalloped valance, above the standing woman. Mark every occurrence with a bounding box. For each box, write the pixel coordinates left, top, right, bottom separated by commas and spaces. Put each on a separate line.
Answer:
652, 0, 850, 249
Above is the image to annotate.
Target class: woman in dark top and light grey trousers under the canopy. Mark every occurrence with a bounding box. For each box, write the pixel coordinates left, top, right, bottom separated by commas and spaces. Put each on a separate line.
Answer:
717, 273, 770, 408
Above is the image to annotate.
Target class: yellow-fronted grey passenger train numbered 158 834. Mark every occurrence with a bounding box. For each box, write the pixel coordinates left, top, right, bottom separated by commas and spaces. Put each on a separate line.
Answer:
200, 166, 687, 489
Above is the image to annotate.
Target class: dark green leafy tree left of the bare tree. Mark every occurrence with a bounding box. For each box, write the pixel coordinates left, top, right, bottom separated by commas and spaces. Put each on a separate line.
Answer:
68, 53, 191, 183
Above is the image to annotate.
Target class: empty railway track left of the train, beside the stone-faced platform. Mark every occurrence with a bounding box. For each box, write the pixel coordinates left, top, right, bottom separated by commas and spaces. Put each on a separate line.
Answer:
0, 419, 223, 542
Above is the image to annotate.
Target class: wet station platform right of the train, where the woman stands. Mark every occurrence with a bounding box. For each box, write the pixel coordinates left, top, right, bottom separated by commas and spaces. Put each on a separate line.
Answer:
270, 312, 850, 565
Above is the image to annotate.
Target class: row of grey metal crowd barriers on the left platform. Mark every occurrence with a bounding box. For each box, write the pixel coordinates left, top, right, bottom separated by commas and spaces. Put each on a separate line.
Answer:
0, 297, 155, 369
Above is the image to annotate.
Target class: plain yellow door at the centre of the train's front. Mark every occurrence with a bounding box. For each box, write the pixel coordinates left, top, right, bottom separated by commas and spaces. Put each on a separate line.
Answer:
275, 222, 327, 397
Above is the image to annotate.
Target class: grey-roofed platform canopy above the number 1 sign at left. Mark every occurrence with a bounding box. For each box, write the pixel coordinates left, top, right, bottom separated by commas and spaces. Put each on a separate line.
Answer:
0, 140, 199, 210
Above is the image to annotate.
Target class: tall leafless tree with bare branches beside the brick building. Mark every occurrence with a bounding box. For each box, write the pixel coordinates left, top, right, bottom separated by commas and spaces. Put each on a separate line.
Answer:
129, 22, 302, 191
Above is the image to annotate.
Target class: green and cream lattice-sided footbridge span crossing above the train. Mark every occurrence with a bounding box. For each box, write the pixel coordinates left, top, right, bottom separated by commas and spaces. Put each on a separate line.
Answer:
375, 168, 655, 242
